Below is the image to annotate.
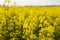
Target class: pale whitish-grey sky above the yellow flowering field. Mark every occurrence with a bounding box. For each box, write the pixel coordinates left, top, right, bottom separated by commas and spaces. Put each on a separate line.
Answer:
0, 0, 60, 6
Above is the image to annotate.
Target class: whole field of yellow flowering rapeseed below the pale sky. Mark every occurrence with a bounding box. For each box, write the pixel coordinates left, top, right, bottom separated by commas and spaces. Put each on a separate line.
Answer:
0, 6, 60, 40
